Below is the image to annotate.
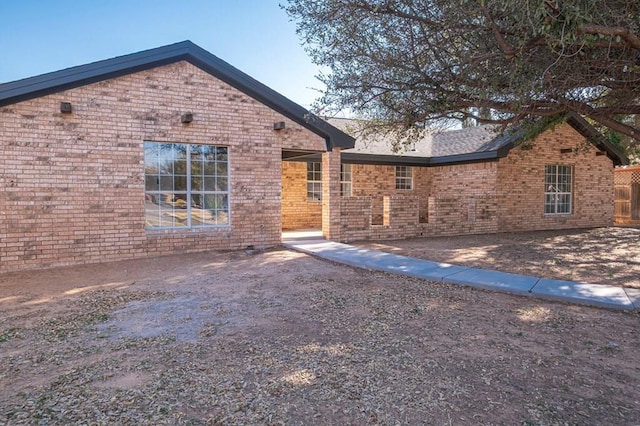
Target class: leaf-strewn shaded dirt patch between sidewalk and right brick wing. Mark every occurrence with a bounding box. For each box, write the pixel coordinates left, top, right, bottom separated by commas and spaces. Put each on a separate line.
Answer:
356, 227, 640, 288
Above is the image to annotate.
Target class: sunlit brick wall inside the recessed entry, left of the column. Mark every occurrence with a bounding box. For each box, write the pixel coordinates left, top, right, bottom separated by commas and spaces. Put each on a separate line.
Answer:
282, 161, 322, 229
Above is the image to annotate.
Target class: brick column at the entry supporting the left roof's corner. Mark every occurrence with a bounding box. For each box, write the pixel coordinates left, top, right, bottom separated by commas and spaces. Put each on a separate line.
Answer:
322, 148, 340, 241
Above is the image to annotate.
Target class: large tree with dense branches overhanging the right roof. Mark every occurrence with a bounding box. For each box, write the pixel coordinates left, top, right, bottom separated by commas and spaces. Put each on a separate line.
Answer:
285, 0, 640, 144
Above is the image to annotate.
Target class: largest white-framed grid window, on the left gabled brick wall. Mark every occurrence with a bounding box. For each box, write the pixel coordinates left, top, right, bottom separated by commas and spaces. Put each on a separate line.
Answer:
144, 141, 229, 229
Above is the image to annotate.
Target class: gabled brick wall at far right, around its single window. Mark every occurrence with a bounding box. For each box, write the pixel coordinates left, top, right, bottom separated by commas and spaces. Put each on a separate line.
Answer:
497, 124, 614, 231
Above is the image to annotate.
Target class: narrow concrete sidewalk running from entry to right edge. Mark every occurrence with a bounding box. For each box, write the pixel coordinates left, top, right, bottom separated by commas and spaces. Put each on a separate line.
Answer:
283, 239, 640, 310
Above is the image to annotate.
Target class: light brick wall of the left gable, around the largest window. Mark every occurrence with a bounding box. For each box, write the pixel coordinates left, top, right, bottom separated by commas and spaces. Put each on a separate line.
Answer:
0, 62, 325, 272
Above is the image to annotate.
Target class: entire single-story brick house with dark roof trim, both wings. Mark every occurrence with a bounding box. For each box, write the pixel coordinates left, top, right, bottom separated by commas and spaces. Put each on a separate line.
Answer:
0, 41, 626, 272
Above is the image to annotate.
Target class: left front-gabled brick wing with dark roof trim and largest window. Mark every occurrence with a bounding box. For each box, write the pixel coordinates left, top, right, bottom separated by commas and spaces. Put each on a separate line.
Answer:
0, 41, 353, 272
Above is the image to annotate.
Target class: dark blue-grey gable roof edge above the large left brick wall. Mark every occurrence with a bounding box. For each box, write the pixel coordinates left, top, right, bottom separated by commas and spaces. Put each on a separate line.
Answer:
0, 41, 355, 150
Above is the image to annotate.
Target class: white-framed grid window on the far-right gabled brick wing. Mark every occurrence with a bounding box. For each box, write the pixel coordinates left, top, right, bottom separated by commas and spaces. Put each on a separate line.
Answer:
544, 164, 573, 214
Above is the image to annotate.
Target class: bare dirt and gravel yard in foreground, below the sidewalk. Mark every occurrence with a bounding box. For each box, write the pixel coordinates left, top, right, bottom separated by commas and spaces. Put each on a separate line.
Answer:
0, 245, 640, 425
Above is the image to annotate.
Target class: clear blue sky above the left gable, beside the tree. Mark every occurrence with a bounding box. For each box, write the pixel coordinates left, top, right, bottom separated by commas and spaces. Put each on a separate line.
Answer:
0, 0, 323, 108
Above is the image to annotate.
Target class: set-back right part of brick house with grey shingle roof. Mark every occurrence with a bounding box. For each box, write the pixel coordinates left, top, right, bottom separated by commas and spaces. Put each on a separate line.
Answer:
282, 114, 627, 241
